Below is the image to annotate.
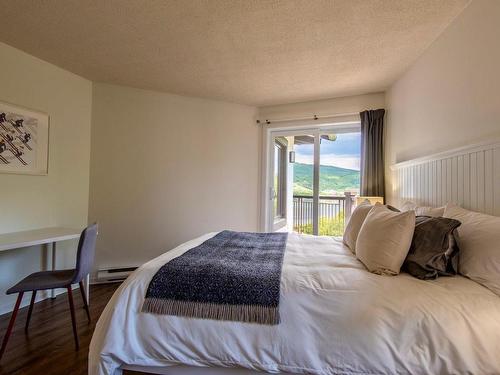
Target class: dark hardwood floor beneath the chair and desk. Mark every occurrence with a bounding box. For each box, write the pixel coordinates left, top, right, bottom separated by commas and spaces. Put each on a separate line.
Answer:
0, 284, 144, 375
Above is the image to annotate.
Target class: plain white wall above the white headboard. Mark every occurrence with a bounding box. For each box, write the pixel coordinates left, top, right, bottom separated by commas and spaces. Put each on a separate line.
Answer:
386, 0, 500, 206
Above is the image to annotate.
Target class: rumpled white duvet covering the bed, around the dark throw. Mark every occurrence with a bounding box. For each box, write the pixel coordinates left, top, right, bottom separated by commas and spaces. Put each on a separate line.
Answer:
89, 233, 500, 375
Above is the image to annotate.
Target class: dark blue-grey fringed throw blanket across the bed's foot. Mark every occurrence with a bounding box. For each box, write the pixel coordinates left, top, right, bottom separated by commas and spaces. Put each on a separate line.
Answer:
142, 230, 288, 324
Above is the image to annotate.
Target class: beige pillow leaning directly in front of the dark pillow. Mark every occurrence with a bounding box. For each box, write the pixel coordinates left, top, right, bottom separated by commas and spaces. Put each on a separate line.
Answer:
356, 205, 415, 275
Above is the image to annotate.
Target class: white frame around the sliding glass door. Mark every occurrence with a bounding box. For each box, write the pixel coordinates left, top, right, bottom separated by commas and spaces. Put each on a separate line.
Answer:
260, 120, 361, 233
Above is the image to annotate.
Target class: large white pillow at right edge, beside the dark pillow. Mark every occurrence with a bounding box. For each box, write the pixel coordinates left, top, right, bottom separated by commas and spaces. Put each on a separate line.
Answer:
444, 204, 500, 295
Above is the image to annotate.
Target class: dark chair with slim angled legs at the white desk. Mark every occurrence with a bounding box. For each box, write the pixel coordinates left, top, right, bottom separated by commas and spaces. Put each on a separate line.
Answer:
0, 224, 97, 359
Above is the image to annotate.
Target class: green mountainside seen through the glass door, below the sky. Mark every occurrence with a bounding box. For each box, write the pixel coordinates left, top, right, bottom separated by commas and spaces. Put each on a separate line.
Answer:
293, 163, 359, 195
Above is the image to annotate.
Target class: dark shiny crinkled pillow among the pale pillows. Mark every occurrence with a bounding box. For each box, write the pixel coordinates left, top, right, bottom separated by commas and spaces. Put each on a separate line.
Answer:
403, 216, 460, 280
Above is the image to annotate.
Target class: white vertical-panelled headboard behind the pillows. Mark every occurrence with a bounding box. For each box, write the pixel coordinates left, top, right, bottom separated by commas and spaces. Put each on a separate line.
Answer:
391, 139, 500, 216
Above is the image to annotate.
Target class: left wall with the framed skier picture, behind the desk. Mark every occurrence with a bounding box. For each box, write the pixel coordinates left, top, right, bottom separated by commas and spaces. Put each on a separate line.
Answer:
0, 43, 92, 313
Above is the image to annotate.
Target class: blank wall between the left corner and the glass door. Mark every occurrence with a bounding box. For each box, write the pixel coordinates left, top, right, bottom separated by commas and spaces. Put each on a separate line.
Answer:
89, 83, 260, 268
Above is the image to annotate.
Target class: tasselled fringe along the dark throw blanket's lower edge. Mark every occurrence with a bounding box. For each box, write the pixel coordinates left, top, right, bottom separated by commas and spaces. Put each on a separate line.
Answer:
142, 298, 280, 325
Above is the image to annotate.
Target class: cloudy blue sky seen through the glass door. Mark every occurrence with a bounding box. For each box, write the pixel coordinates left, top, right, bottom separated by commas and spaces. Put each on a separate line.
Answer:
294, 133, 361, 171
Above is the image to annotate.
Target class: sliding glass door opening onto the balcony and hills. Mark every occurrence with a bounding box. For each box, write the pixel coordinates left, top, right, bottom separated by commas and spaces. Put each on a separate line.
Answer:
268, 125, 360, 236
